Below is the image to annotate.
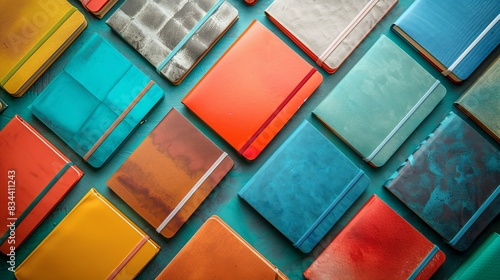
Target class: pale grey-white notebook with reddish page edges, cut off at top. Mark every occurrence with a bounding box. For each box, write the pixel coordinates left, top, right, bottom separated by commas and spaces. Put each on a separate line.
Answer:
265, 0, 398, 74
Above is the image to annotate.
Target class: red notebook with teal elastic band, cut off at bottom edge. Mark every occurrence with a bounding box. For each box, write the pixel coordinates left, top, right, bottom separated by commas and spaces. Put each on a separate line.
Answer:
304, 195, 446, 280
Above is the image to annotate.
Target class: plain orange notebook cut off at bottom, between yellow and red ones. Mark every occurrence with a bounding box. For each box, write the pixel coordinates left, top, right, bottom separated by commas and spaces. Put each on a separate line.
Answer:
156, 216, 288, 280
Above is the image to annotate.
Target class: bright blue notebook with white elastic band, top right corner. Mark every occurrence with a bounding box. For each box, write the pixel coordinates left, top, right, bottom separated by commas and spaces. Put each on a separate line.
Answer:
392, 0, 500, 83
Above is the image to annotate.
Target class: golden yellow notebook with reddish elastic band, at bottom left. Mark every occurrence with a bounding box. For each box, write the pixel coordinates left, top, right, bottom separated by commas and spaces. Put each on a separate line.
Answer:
14, 189, 160, 280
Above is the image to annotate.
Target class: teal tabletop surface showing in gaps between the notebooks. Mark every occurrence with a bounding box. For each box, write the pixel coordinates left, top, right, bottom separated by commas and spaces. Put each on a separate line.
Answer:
0, 0, 500, 279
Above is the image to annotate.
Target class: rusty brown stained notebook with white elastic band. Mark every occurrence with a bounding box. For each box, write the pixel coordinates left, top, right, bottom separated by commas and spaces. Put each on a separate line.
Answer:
107, 109, 233, 238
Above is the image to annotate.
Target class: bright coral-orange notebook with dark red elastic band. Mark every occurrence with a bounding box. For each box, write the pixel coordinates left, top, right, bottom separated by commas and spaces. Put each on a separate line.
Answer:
182, 20, 323, 160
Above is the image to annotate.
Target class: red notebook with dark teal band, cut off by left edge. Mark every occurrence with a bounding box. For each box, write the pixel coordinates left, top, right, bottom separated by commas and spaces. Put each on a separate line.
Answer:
0, 115, 83, 254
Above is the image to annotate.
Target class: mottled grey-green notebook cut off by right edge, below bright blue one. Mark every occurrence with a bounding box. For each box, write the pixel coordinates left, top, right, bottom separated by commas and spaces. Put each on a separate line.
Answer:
455, 59, 500, 142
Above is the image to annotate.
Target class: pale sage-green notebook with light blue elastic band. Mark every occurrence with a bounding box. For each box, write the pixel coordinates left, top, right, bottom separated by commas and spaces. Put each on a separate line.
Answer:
313, 35, 446, 167
